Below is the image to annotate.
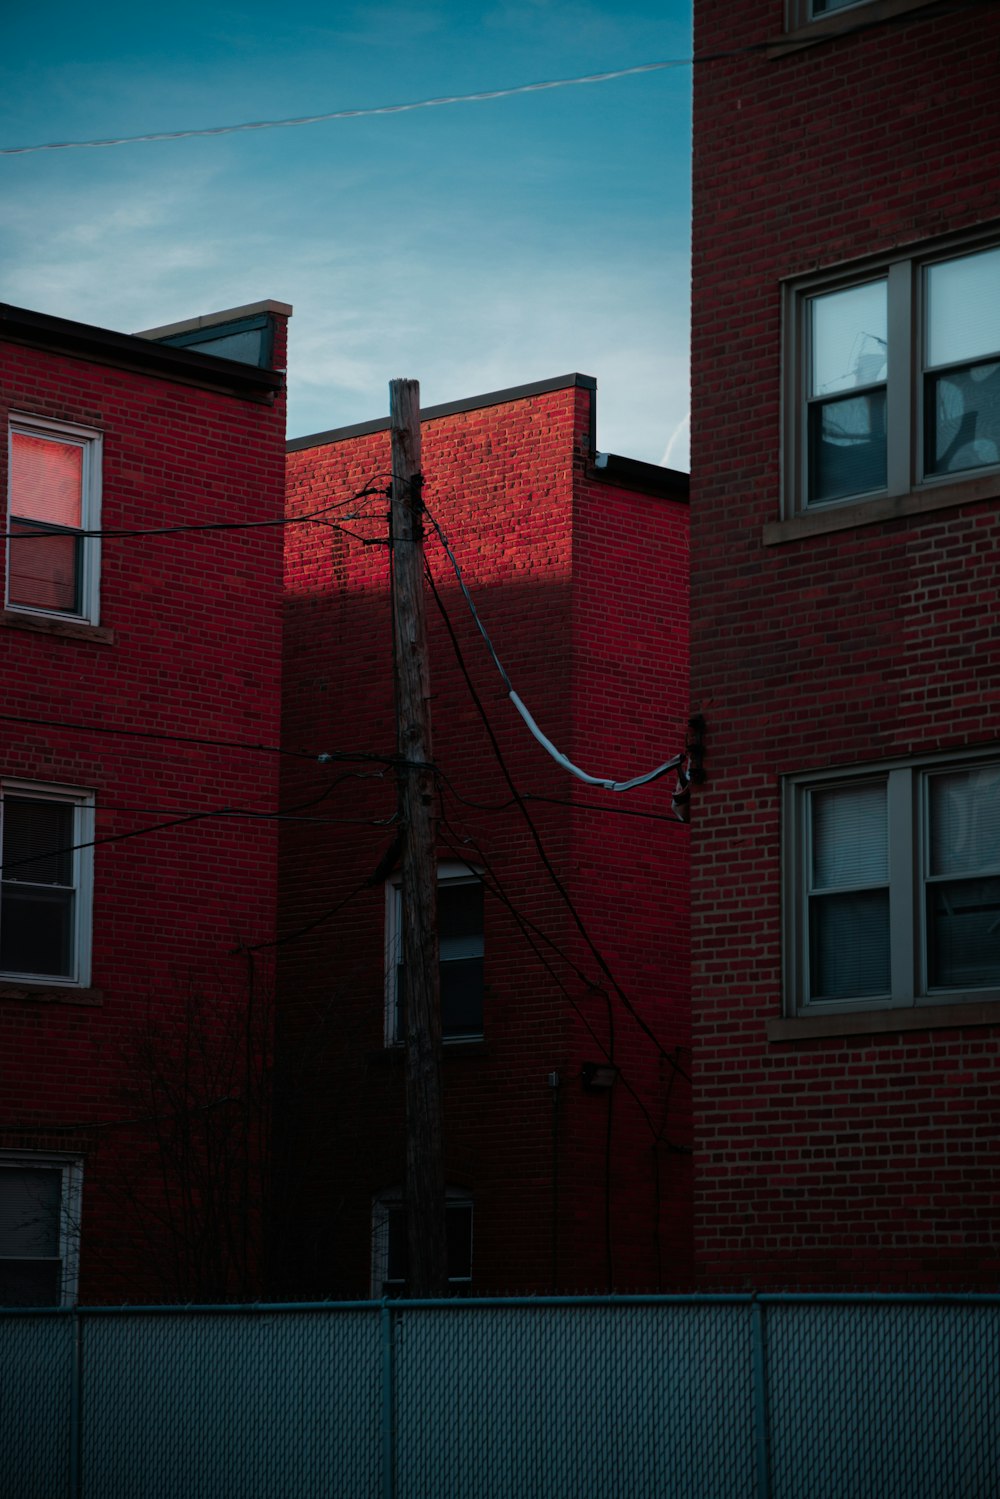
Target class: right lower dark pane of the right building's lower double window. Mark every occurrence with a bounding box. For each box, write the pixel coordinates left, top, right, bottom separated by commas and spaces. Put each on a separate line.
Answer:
927, 878, 1000, 989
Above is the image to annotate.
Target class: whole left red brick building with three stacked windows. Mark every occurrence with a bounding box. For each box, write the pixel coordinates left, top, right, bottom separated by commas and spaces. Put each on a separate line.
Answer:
0, 303, 291, 1303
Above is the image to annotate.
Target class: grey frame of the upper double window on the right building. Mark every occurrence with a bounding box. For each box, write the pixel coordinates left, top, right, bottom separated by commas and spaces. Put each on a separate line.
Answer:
781, 223, 1000, 522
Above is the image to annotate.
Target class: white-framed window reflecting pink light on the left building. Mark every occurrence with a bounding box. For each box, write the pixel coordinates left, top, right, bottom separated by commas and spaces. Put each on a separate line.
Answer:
6, 417, 100, 625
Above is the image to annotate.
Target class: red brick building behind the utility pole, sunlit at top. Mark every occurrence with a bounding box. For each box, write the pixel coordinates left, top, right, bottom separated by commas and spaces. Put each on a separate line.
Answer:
277, 375, 690, 1295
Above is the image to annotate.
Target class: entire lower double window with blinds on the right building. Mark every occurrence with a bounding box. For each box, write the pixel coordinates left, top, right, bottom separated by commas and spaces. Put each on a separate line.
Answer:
784, 758, 1000, 1013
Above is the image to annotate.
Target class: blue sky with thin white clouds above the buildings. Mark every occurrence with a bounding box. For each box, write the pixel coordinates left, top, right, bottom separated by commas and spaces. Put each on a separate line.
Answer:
0, 0, 691, 468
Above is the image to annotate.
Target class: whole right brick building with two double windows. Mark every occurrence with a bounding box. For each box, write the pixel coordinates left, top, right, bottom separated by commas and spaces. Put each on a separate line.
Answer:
691, 0, 1000, 1288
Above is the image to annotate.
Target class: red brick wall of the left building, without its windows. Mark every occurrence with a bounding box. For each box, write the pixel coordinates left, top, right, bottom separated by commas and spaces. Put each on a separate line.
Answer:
0, 319, 285, 1301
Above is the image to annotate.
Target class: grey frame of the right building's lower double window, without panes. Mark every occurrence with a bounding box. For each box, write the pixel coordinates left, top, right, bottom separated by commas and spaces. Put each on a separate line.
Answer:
781, 748, 1000, 1018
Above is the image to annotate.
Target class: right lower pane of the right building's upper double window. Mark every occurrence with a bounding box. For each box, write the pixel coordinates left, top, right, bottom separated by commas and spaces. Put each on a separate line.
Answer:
925, 360, 1000, 474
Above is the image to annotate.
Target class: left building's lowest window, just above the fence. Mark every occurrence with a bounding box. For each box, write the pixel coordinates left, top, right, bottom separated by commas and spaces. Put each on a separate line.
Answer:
0, 1156, 82, 1307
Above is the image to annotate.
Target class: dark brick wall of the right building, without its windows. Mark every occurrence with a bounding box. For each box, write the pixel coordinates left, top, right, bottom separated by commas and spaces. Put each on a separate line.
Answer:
691, 0, 1000, 1288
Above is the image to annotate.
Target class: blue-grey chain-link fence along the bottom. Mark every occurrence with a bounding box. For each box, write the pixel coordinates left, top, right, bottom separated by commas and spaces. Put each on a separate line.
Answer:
0, 1295, 1000, 1499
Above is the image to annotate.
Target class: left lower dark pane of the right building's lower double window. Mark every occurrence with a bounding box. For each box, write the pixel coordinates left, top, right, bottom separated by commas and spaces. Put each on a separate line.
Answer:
810, 890, 889, 1000
